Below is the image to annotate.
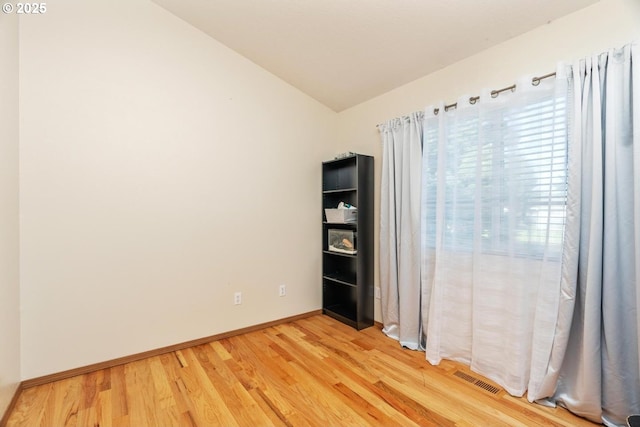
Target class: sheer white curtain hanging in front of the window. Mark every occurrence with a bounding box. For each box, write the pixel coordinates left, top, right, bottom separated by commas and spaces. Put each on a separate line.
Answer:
422, 80, 568, 396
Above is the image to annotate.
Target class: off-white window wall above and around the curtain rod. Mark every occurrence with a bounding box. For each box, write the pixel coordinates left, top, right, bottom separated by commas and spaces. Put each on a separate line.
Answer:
339, 0, 640, 321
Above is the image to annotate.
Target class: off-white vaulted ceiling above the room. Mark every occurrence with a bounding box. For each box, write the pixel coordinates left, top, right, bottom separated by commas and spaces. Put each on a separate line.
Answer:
153, 0, 598, 111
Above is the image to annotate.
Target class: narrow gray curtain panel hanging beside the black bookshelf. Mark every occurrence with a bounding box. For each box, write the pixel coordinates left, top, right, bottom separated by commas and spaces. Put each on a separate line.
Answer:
379, 113, 424, 350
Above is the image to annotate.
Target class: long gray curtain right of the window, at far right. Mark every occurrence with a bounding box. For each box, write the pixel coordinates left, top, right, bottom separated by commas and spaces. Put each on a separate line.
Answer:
550, 45, 640, 425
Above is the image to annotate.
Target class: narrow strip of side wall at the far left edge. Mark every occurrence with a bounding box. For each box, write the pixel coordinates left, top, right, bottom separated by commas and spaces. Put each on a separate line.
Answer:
0, 13, 20, 418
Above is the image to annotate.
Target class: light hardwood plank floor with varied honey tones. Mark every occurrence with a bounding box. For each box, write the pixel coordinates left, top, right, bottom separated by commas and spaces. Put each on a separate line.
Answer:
7, 315, 596, 427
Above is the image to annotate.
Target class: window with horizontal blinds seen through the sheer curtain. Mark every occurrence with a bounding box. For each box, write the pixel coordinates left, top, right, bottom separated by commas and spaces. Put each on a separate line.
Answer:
423, 92, 568, 258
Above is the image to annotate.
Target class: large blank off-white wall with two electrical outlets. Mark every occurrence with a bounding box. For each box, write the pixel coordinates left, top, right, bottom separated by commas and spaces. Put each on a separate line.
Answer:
20, 0, 337, 379
